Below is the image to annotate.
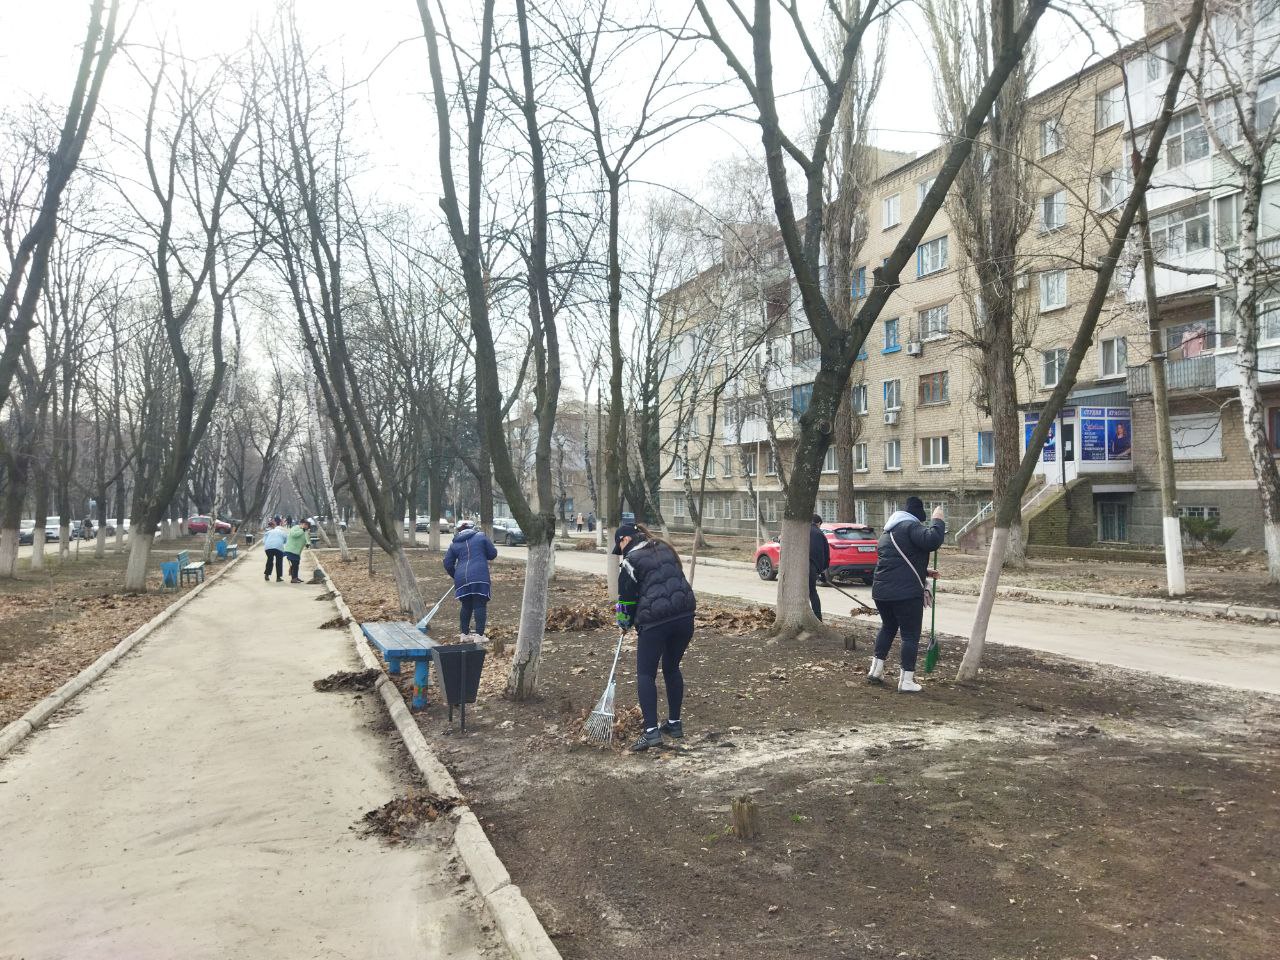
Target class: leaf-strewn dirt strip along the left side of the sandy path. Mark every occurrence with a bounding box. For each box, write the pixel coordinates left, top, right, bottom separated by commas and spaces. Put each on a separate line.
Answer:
0, 543, 217, 727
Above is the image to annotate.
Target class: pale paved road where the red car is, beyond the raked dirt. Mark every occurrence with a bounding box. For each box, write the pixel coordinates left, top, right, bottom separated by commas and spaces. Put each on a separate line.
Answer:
498, 547, 1280, 694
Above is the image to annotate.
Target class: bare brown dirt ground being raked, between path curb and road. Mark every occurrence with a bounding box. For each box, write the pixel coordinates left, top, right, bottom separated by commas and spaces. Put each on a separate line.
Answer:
329, 552, 1280, 960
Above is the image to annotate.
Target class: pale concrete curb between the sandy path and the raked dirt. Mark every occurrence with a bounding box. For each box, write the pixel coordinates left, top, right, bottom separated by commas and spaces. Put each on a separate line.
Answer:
316, 561, 561, 960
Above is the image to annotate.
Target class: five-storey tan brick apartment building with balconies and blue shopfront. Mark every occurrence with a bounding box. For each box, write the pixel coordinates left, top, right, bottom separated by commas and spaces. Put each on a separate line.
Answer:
662, 3, 1280, 547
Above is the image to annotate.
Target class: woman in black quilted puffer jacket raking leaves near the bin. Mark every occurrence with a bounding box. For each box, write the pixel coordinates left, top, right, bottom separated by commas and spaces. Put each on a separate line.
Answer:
613, 524, 698, 751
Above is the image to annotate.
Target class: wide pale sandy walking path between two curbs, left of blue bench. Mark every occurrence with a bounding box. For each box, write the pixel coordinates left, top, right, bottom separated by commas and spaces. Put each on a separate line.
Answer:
0, 553, 506, 960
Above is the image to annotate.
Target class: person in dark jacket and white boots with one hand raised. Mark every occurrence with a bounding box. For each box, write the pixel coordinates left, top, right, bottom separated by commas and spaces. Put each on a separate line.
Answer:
867, 497, 947, 694
